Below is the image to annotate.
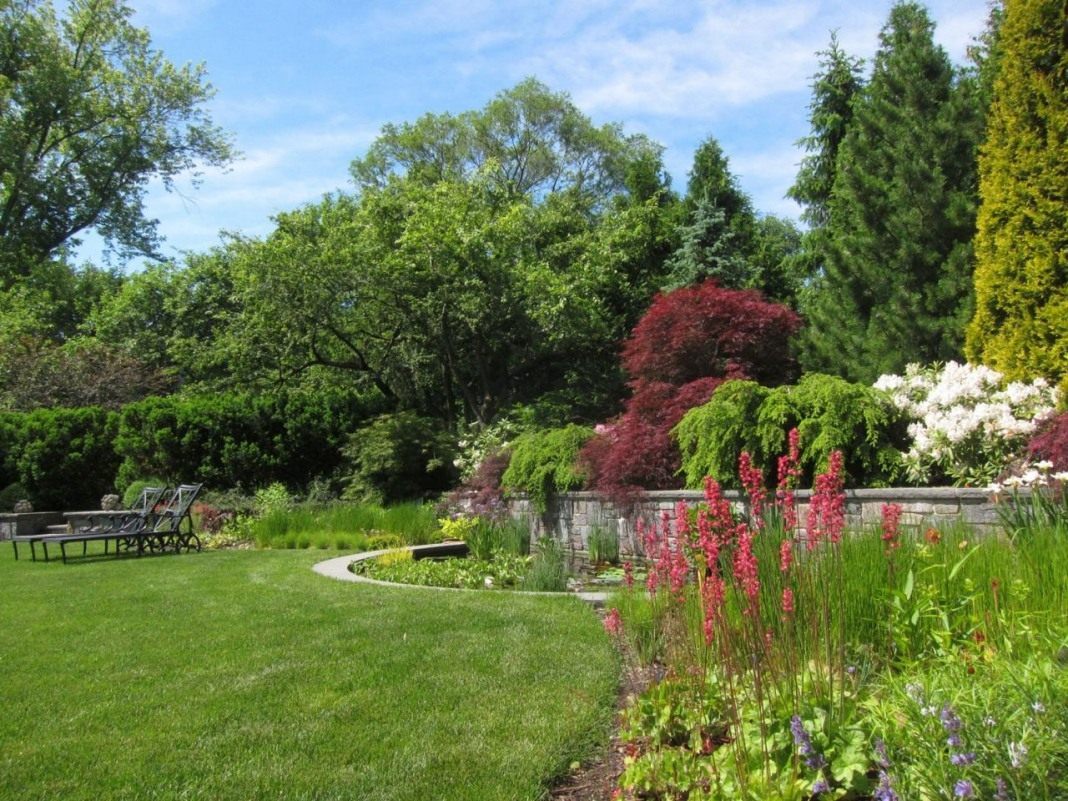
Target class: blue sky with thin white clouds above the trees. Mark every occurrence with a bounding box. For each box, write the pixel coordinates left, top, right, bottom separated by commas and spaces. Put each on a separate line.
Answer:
79, 0, 987, 267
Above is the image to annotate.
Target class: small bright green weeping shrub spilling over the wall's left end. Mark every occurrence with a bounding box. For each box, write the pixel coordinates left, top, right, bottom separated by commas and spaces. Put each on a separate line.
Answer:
501, 424, 594, 513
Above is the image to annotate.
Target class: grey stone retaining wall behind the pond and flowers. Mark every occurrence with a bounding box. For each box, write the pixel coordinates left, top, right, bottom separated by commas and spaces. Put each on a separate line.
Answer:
511, 487, 1008, 555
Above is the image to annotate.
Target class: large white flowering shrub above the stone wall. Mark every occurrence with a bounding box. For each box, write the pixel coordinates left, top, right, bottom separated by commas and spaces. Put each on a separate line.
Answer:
875, 362, 1057, 486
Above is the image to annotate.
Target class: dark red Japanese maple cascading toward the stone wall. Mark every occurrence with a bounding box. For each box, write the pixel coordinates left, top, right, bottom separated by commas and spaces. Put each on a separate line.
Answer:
581, 281, 801, 500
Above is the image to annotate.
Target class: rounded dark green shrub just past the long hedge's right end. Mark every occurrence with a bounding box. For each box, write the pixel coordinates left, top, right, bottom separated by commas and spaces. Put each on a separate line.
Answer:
342, 411, 455, 504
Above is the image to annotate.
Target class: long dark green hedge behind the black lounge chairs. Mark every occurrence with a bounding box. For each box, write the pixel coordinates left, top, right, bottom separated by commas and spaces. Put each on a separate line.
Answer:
0, 393, 381, 509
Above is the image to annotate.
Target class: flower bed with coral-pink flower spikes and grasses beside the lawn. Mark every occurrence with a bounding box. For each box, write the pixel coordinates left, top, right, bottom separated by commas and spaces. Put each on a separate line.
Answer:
606, 435, 1068, 801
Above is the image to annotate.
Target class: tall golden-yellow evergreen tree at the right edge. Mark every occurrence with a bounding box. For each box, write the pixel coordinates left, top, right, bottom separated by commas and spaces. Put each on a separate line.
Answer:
968, 0, 1068, 379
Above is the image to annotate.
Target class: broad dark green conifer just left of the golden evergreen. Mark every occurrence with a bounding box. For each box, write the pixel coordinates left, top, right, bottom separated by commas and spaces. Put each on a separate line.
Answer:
804, 2, 981, 381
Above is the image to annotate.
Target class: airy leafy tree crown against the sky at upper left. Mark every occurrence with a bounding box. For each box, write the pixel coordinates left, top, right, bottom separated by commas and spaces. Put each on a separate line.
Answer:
0, 0, 232, 279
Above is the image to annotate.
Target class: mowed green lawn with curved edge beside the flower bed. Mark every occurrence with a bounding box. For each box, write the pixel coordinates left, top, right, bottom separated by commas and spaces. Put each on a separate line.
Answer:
0, 543, 618, 801
